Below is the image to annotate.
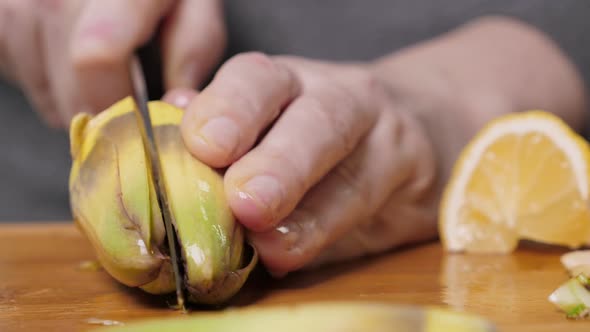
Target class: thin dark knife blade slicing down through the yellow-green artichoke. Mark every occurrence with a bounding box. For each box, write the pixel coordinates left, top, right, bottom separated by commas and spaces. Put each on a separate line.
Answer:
129, 52, 185, 310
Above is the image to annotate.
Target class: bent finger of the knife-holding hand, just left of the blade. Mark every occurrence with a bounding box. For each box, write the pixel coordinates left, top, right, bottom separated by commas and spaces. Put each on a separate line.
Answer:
69, 0, 173, 112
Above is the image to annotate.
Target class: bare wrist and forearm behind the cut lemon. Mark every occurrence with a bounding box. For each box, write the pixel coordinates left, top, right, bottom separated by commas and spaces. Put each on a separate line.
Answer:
370, 18, 586, 196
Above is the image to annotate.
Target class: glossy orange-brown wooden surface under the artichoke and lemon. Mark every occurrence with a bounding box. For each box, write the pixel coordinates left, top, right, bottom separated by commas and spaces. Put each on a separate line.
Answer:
0, 223, 590, 331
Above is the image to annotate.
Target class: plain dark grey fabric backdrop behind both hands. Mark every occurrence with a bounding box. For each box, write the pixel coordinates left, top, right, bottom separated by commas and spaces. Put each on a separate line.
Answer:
0, 0, 590, 221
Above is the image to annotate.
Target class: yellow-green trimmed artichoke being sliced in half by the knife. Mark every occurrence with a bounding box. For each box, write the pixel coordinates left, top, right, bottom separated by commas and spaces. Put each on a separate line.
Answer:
69, 97, 257, 304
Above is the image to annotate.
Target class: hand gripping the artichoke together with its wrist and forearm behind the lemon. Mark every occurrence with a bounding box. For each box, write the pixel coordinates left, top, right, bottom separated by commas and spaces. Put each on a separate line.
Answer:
168, 17, 587, 275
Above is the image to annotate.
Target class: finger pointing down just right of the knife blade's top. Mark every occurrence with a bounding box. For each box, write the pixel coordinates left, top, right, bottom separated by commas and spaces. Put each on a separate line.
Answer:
162, 0, 226, 89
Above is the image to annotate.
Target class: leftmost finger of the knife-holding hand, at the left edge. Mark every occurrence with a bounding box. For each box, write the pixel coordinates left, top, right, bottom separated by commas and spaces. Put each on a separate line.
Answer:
0, 1, 61, 127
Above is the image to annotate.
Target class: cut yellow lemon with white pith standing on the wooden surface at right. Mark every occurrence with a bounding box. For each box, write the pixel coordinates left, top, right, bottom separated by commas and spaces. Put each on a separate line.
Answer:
439, 111, 590, 253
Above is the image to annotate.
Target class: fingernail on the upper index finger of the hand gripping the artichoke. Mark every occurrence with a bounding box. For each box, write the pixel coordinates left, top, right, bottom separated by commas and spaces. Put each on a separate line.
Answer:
199, 116, 240, 153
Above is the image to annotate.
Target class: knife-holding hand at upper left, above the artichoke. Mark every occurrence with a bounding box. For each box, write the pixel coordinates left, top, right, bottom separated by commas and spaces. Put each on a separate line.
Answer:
0, 0, 226, 127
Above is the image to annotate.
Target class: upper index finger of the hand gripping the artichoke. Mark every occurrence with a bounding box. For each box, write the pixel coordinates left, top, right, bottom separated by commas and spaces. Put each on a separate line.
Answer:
181, 53, 300, 167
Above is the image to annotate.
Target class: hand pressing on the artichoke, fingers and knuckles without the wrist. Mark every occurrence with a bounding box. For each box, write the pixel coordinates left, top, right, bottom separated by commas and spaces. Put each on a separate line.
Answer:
173, 53, 436, 275
